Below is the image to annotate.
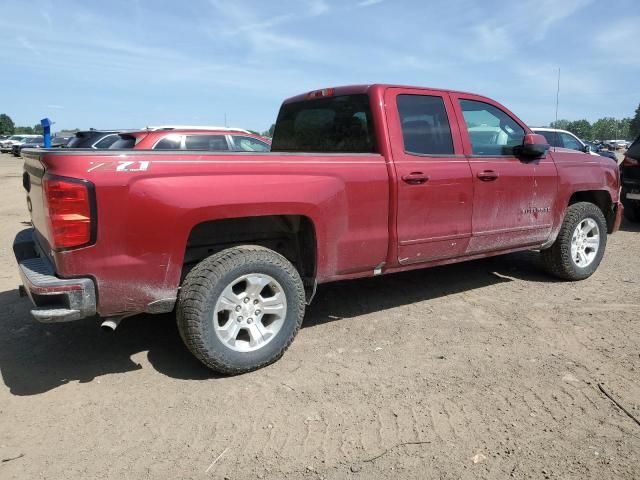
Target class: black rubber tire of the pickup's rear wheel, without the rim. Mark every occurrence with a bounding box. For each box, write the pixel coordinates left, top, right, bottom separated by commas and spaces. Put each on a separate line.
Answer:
176, 246, 305, 375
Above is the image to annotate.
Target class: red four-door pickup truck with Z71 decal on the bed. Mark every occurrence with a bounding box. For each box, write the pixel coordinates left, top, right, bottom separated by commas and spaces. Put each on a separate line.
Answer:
14, 85, 623, 373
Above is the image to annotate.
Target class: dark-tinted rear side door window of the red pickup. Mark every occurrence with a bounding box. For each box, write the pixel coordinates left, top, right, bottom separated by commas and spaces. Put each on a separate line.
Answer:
398, 95, 454, 155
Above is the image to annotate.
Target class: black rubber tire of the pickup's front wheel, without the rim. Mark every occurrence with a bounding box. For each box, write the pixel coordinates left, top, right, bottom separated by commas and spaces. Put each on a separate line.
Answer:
541, 202, 607, 281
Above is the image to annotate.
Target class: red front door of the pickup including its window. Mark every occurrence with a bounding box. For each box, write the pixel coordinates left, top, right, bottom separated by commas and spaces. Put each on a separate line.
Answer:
452, 94, 557, 254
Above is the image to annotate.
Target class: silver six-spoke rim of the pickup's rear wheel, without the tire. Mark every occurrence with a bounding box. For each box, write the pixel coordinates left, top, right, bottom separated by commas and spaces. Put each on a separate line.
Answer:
213, 273, 287, 352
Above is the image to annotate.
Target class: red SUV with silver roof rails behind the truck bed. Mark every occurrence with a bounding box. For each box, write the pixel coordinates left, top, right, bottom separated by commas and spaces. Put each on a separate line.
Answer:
109, 126, 271, 152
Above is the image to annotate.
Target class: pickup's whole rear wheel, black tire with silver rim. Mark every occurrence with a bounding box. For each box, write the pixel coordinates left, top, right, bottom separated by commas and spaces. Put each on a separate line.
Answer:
177, 246, 305, 374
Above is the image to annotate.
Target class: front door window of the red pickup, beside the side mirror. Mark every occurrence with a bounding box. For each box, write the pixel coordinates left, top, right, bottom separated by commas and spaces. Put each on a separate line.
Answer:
460, 100, 524, 156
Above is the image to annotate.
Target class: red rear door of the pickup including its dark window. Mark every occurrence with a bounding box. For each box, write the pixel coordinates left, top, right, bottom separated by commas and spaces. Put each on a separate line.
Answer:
385, 88, 473, 264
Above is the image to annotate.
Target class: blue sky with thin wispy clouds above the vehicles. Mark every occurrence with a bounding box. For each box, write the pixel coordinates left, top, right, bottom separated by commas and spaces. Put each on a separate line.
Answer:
0, 0, 640, 130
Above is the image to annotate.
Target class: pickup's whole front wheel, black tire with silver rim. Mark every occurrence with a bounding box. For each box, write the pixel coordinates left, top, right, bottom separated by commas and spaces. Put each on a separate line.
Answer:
542, 202, 607, 280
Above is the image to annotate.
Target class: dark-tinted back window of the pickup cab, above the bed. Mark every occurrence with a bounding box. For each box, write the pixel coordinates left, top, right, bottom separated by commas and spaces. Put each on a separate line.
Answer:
271, 94, 376, 153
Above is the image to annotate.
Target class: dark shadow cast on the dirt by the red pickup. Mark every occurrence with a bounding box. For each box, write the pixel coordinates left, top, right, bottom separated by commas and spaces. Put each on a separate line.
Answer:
0, 249, 553, 396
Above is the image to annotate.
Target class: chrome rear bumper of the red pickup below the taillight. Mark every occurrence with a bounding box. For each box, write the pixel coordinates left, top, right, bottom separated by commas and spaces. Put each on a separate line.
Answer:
13, 228, 96, 323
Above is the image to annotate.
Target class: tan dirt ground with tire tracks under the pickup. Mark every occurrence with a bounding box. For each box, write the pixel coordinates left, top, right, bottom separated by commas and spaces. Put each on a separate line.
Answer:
0, 151, 640, 480
